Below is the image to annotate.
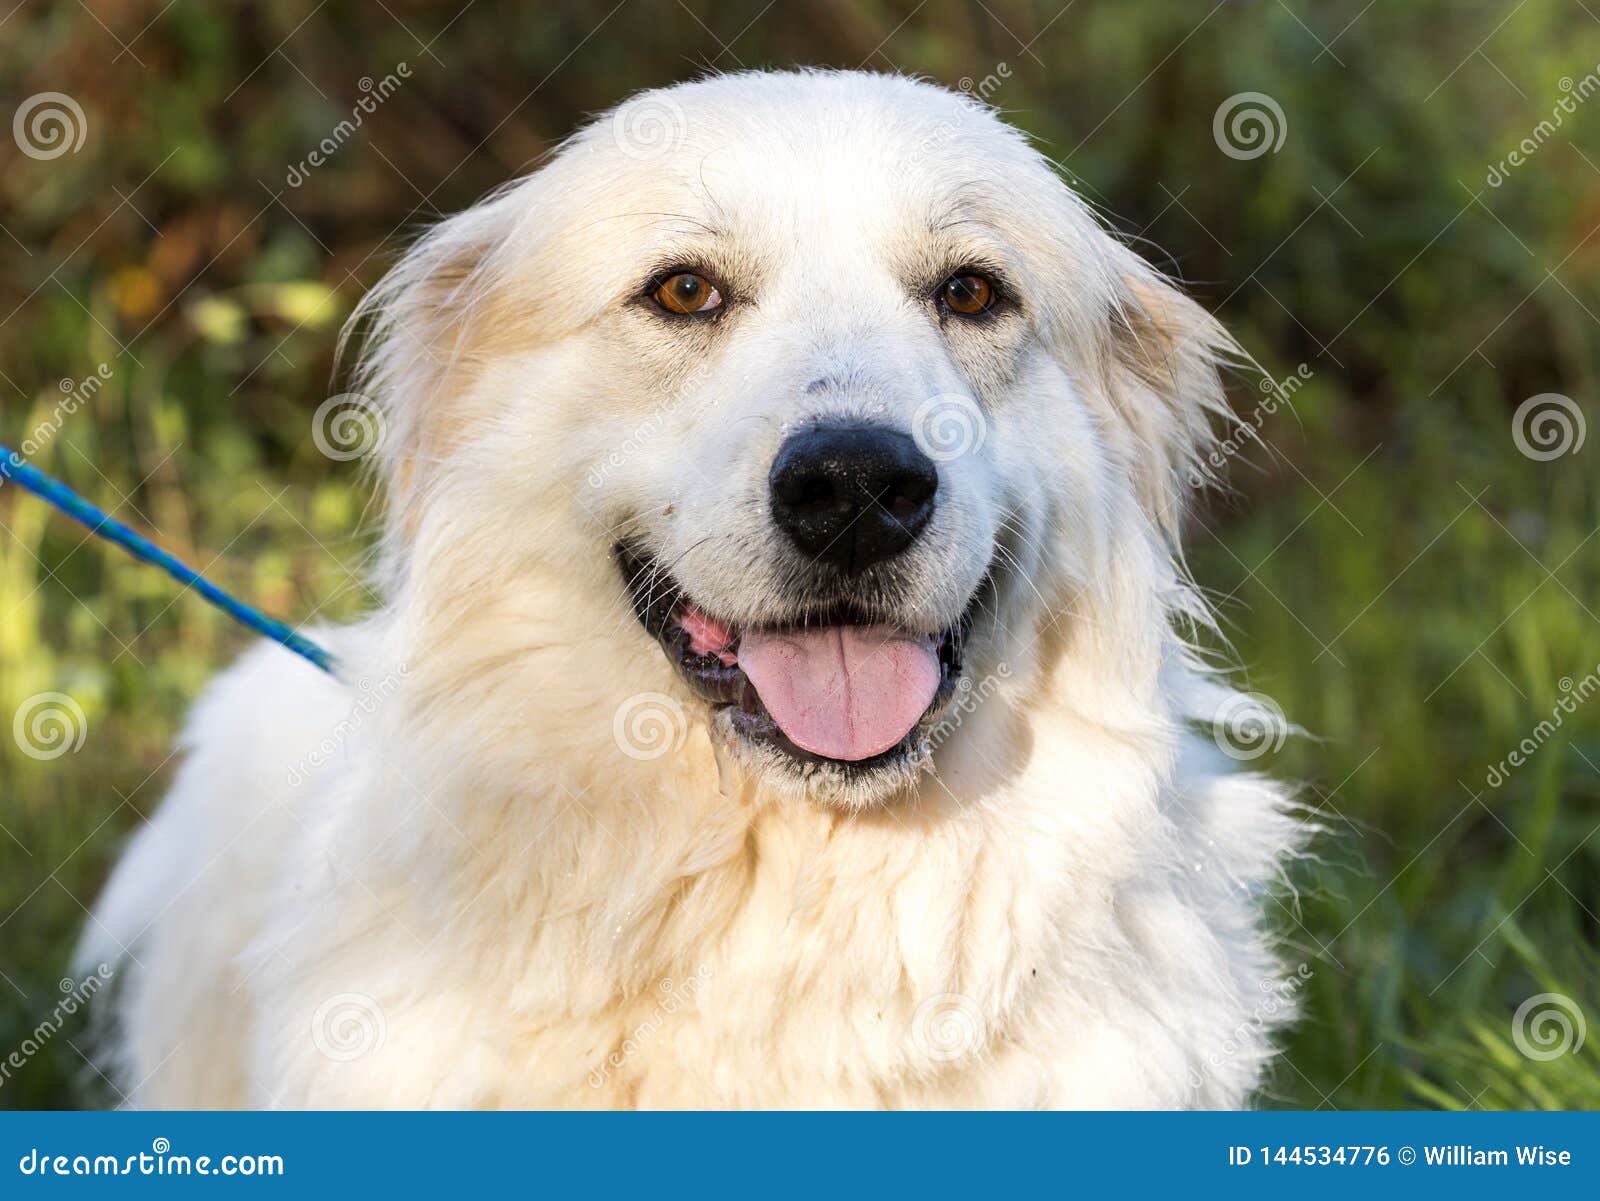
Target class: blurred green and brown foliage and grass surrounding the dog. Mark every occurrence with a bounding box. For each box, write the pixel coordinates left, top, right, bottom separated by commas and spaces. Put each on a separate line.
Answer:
0, 0, 1600, 1107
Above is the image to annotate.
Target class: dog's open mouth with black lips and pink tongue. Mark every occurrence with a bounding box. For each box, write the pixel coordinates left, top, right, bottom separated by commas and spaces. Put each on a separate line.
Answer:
616, 545, 987, 771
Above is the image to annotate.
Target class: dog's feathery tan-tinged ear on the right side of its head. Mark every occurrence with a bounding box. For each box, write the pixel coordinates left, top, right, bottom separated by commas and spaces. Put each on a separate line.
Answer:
1104, 267, 1248, 537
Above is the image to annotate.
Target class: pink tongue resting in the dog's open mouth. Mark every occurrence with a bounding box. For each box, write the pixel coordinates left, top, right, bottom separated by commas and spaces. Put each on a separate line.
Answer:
739, 625, 939, 761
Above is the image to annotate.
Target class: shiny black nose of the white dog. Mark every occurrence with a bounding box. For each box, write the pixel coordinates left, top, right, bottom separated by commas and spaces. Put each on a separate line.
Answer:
770, 425, 939, 573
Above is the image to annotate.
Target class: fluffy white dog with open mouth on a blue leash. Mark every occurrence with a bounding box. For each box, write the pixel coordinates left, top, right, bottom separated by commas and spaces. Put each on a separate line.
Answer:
82, 72, 1304, 1107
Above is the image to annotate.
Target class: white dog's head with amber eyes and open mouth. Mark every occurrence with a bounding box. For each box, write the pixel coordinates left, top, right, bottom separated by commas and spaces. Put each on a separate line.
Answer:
366, 74, 1230, 803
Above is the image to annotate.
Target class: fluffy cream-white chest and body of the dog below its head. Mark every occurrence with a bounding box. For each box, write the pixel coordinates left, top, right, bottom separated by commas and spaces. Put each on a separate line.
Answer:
81, 620, 1294, 1107
